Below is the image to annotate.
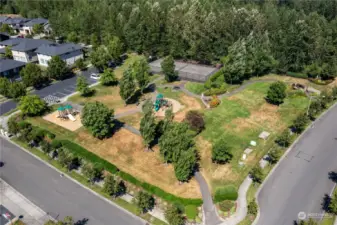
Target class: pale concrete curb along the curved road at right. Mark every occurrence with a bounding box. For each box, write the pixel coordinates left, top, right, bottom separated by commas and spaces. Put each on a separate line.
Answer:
252, 102, 337, 225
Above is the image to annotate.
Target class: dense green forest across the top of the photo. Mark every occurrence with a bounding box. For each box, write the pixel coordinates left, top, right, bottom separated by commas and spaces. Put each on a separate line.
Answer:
0, 0, 337, 78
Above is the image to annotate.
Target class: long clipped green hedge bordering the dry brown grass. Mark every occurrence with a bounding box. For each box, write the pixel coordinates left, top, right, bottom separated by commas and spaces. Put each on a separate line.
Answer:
52, 140, 202, 206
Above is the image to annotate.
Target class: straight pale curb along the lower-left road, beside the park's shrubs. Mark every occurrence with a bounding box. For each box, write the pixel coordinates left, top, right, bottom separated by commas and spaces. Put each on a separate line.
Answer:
4, 138, 148, 224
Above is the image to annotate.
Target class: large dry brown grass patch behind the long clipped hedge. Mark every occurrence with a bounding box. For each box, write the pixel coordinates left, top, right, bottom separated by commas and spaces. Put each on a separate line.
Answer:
76, 129, 201, 198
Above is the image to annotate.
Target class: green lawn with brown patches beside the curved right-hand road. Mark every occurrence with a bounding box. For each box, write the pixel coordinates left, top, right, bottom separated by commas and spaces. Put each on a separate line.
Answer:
198, 82, 308, 191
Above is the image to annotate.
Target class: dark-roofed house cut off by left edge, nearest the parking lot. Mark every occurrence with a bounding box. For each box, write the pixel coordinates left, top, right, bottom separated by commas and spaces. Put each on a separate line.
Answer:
0, 59, 26, 80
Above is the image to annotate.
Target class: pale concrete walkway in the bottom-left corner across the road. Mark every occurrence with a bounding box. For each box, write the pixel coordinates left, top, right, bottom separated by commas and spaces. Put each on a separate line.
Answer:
0, 179, 53, 225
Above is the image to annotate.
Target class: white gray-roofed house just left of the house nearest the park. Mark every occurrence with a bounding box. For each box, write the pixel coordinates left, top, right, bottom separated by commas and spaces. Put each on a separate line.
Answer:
12, 38, 53, 63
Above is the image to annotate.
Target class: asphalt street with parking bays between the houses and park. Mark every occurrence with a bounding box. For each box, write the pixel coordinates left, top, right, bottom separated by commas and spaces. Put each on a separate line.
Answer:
0, 68, 97, 116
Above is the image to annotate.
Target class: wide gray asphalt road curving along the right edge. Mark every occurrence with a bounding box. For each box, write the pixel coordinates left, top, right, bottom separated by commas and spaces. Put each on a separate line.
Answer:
257, 104, 337, 225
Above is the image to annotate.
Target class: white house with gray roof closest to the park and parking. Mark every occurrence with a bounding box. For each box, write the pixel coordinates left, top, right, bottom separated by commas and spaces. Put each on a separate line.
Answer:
35, 43, 83, 66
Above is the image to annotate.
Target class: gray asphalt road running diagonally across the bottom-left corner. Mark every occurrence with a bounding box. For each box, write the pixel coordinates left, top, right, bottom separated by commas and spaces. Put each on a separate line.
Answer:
0, 138, 145, 225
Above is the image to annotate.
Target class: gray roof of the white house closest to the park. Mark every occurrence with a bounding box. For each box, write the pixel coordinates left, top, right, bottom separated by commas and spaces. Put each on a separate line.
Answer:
35, 43, 82, 56
